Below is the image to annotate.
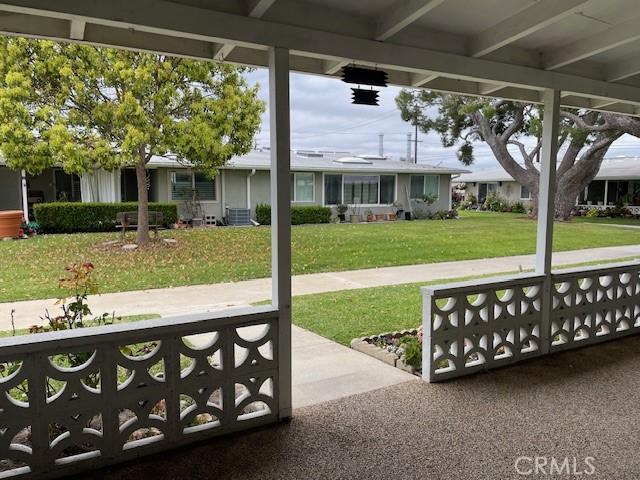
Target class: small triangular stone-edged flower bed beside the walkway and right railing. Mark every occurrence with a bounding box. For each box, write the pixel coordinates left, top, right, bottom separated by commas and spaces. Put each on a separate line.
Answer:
351, 327, 422, 376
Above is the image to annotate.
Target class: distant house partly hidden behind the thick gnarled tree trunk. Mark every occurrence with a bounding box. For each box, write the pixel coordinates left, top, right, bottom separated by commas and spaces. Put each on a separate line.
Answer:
454, 157, 640, 213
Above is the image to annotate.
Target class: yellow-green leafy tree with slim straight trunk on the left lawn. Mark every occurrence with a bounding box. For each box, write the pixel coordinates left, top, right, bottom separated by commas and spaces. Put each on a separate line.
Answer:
0, 38, 264, 245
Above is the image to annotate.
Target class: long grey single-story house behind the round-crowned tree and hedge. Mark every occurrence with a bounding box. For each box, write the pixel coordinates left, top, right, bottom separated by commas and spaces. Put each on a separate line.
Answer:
0, 149, 466, 224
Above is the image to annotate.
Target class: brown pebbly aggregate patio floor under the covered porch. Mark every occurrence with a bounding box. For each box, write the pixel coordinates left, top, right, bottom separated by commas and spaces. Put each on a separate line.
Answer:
84, 336, 640, 480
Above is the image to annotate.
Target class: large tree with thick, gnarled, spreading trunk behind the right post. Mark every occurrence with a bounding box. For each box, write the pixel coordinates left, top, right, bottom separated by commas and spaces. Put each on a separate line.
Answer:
396, 90, 628, 219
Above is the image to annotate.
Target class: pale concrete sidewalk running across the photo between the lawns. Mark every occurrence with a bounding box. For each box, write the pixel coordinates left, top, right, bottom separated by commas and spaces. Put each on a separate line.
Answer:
0, 245, 640, 329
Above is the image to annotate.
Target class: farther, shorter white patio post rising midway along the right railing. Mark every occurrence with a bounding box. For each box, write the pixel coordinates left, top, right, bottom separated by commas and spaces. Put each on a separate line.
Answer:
536, 90, 560, 354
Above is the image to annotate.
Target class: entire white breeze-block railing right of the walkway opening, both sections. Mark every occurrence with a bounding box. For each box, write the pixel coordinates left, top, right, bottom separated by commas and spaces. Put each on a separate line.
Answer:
422, 262, 640, 382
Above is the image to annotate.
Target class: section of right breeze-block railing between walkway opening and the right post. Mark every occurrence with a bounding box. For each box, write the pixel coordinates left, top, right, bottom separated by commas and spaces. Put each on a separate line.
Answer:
422, 274, 544, 382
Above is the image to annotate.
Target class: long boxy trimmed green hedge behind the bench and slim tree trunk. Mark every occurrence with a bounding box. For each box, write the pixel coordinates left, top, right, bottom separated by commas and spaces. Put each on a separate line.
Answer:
33, 202, 178, 233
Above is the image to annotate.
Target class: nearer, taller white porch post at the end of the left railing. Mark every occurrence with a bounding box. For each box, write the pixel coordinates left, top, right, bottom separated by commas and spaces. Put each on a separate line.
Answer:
269, 47, 291, 420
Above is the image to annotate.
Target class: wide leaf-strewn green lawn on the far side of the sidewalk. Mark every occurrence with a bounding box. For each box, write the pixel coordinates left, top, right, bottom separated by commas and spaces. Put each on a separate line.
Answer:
0, 212, 640, 301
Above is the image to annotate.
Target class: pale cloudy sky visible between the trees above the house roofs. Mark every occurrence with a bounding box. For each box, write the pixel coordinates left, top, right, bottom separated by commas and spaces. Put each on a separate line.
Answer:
247, 68, 640, 170
